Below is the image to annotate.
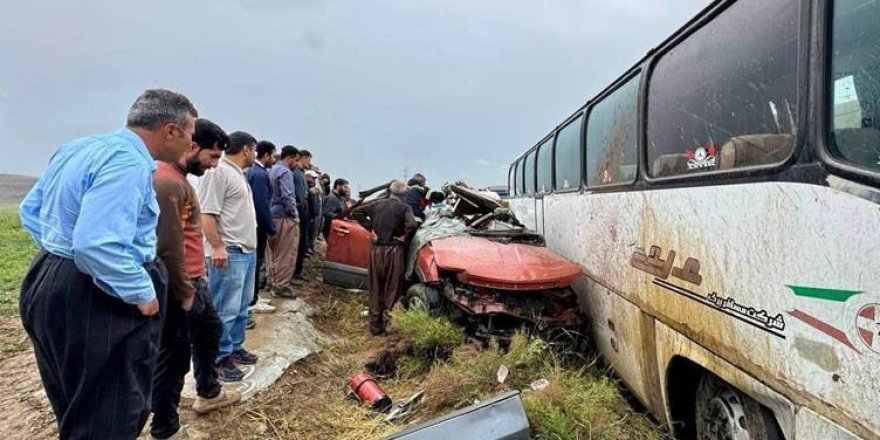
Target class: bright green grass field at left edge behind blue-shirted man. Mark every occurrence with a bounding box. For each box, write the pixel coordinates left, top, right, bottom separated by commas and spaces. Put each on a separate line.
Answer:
0, 210, 36, 316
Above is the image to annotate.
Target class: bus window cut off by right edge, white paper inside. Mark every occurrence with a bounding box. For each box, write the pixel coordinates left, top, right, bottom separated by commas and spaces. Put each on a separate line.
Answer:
830, 0, 880, 171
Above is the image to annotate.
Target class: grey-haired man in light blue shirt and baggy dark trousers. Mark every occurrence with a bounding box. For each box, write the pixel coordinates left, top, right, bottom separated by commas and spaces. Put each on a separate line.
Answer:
19, 90, 198, 439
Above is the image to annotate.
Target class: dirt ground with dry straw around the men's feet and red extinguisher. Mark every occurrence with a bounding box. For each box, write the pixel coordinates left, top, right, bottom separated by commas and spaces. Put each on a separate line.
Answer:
0, 248, 661, 440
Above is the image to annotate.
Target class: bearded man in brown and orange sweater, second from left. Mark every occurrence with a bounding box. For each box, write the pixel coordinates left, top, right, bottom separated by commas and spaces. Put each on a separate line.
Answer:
150, 119, 241, 439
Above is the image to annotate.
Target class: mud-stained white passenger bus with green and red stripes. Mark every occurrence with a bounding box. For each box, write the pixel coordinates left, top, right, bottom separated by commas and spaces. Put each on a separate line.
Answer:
509, 0, 880, 440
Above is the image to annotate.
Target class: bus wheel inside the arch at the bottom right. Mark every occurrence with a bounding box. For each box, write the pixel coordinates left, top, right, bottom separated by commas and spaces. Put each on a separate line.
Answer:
694, 373, 783, 440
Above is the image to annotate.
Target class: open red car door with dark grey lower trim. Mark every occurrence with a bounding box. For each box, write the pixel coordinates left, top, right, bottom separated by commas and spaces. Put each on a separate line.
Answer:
324, 218, 372, 289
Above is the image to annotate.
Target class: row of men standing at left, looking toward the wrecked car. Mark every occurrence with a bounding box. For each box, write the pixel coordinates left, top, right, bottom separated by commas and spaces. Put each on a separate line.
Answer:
20, 89, 347, 439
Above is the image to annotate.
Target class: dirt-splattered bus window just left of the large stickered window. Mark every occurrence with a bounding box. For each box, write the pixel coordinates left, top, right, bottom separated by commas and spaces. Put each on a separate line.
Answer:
587, 75, 641, 186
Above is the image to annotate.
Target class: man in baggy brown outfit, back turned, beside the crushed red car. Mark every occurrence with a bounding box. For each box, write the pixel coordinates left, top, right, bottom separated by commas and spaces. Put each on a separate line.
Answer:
352, 180, 418, 336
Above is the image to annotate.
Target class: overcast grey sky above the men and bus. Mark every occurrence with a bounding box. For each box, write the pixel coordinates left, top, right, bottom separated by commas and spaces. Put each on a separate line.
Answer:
0, 0, 708, 188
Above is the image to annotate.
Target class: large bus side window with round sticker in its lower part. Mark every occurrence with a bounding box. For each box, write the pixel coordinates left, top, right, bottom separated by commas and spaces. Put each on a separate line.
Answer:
647, 0, 800, 177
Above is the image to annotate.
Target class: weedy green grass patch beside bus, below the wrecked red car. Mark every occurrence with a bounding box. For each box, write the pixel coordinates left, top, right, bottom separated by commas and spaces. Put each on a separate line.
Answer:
391, 309, 664, 440
